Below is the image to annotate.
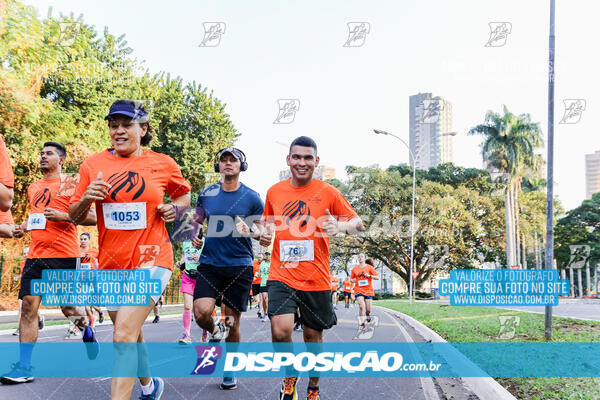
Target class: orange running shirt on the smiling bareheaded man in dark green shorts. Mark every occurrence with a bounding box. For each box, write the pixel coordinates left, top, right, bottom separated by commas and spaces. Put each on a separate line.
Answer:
263, 179, 357, 291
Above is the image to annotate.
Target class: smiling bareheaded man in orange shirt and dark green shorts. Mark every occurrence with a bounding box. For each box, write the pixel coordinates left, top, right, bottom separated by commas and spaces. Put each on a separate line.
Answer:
260, 136, 364, 400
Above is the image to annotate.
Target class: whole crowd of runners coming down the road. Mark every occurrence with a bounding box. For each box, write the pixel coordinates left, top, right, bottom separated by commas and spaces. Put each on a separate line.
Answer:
0, 100, 378, 400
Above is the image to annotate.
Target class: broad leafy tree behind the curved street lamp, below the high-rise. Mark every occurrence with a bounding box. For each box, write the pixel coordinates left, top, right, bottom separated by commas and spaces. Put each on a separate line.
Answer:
332, 167, 502, 288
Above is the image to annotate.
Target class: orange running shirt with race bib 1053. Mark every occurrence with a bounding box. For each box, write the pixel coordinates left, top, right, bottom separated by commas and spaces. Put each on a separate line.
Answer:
71, 149, 190, 270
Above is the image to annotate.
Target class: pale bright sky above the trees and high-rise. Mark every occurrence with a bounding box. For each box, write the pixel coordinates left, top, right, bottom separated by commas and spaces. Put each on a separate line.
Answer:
25, 0, 600, 210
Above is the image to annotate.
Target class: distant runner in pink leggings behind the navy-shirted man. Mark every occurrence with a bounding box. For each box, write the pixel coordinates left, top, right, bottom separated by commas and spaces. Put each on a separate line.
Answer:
175, 239, 208, 344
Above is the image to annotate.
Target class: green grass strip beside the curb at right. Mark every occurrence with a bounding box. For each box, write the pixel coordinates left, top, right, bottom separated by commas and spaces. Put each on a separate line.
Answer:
374, 300, 600, 400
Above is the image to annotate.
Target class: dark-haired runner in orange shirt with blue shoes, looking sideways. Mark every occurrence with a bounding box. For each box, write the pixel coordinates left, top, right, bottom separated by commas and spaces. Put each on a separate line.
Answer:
0, 142, 98, 384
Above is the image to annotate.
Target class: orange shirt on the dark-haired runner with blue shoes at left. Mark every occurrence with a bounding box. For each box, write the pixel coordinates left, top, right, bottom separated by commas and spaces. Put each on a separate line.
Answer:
27, 178, 79, 258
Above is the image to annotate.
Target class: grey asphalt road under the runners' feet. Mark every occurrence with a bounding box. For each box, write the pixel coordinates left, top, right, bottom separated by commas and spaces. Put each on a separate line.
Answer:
0, 307, 473, 400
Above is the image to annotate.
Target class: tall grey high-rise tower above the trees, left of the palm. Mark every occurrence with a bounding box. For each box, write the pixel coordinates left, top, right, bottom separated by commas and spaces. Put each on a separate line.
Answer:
409, 93, 453, 169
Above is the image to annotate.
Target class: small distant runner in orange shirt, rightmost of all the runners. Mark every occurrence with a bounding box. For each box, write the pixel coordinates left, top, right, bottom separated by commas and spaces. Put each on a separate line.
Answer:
350, 253, 379, 329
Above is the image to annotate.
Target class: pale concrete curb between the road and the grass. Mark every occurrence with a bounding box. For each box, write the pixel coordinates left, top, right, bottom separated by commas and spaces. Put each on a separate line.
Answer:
374, 306, 517, 400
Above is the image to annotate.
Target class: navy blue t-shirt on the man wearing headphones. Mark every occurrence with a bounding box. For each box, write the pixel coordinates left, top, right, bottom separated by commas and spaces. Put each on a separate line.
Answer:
196, 182, 265, 267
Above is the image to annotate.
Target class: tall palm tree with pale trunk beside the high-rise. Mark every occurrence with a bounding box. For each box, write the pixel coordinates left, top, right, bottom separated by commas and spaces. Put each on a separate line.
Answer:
468, 106, 543, 266
